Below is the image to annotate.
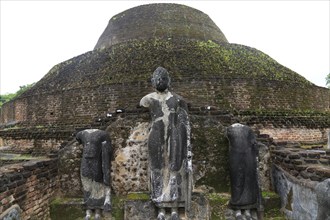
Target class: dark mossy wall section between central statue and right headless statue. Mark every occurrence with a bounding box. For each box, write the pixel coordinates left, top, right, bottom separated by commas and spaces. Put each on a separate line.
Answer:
191, 116, 229, 192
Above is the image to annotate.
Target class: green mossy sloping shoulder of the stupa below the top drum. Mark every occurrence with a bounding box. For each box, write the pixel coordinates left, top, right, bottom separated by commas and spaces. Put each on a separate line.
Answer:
27, 38, 310, 91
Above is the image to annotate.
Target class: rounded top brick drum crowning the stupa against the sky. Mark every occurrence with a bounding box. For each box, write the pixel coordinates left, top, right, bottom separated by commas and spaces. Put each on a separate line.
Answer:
94, 4, 228, 49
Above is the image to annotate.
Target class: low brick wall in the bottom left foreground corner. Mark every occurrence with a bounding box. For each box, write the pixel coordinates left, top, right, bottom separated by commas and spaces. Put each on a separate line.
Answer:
0, 159, 57, 220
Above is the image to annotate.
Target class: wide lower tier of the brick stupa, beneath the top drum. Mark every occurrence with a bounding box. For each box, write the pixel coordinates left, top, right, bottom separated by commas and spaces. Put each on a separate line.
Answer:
0, 40, 330, 130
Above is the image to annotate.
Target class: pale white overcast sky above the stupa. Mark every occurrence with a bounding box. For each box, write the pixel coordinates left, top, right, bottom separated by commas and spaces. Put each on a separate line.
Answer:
0, 0, 330, 94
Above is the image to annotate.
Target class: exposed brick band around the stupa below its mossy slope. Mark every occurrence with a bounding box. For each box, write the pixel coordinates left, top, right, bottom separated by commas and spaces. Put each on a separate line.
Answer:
0, 79, 326, 130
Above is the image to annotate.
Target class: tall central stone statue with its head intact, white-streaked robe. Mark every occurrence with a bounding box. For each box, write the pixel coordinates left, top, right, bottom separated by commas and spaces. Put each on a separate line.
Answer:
140, 67, 192, 220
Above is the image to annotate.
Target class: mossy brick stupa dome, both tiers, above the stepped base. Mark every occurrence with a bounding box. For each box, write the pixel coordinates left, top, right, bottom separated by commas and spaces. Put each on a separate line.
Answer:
1, 4, 330, 130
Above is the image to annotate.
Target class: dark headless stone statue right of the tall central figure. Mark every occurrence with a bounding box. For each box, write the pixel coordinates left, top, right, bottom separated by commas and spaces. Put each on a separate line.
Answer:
226, 123, 263, 219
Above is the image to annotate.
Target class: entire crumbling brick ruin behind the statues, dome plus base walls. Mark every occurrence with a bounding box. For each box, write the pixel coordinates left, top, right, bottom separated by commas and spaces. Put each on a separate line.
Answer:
0, 4, 330, 219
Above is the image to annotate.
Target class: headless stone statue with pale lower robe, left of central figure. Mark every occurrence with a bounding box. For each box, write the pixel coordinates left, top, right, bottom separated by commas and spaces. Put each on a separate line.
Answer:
76, 129, 111, 220
